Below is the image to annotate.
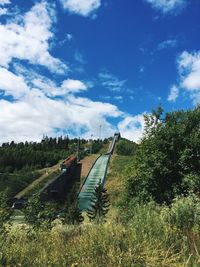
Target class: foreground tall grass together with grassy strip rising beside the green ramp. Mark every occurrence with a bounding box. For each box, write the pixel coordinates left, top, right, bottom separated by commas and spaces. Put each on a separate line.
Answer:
0, 156, 200, 267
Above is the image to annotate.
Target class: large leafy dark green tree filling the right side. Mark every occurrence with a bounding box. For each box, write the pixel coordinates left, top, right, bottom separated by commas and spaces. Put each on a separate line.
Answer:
126, 106, 200, 203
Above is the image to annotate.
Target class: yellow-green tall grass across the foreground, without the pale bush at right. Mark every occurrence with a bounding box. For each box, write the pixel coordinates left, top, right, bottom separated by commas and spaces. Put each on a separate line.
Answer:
0, 203, 200, 267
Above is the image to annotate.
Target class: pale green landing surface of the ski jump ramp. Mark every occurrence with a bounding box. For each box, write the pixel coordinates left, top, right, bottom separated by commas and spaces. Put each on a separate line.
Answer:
78, 154, 110, 211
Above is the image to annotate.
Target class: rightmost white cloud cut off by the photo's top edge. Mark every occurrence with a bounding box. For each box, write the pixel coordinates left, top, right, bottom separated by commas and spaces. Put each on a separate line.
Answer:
145, 0, 188, 14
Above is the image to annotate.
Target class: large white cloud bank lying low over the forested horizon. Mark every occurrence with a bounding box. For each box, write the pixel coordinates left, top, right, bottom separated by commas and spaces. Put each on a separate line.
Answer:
0, 65, 143, 143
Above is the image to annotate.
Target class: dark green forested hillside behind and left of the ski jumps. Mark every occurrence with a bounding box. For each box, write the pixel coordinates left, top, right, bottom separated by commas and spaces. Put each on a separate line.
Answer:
0, 137, 104, 197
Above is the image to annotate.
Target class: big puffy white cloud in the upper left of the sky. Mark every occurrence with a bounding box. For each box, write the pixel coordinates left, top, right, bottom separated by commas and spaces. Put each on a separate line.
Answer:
0, 2, 67, 73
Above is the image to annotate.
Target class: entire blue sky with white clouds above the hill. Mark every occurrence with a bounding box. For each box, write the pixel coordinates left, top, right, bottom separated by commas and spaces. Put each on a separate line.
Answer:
0, 0, 200, 143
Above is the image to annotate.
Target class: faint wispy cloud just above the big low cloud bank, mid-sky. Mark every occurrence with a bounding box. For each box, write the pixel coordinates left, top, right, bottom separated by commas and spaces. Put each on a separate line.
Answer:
99, 71, 126, 92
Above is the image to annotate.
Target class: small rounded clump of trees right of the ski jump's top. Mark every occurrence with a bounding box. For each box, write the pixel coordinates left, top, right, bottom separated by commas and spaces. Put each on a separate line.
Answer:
116, 139, 137, 156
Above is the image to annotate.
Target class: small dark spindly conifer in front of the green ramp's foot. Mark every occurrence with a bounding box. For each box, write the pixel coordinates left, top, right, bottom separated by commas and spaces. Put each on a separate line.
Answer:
87, 181, 110, 223
